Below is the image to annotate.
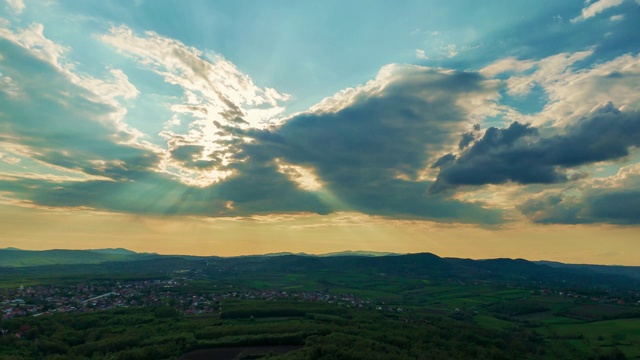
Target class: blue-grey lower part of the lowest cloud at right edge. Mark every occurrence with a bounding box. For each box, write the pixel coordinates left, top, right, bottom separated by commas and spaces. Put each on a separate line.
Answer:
518, 188, 640, 225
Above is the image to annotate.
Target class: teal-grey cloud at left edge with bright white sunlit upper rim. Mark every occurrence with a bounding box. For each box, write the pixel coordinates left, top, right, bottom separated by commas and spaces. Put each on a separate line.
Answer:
0, 24, 159, 186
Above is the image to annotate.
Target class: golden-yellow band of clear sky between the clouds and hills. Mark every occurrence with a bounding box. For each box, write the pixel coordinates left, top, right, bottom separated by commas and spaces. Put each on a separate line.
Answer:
5, 206, 640, 266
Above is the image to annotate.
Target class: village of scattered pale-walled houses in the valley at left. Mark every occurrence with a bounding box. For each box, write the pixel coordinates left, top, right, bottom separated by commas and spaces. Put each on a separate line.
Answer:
0, 278, 371, 319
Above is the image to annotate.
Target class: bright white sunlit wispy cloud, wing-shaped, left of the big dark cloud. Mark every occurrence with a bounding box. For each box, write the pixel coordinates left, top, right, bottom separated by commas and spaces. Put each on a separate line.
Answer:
100, 26, 290, 186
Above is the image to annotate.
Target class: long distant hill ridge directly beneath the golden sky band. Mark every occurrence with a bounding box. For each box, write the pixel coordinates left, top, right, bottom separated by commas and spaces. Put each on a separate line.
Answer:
0, 247, 640, 280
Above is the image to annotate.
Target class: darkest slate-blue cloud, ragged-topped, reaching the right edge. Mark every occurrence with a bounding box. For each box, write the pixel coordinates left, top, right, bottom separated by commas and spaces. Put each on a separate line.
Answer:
430, 103, 640, 192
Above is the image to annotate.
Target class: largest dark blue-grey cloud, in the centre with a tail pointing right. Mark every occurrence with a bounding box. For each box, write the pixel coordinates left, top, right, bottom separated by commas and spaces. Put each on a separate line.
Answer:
228, 69, 501, 223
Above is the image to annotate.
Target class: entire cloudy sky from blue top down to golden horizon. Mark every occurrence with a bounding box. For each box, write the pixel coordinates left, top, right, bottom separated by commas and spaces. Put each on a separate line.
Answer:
0, 0, 640, 265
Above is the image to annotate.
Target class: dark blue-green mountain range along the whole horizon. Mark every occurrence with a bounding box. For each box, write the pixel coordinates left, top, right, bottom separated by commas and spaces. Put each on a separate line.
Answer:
0, 248, 640, 287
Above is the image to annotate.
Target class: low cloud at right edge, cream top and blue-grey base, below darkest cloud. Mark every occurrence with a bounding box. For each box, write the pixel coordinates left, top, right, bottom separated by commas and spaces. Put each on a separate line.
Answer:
518, 164, 640, 225
